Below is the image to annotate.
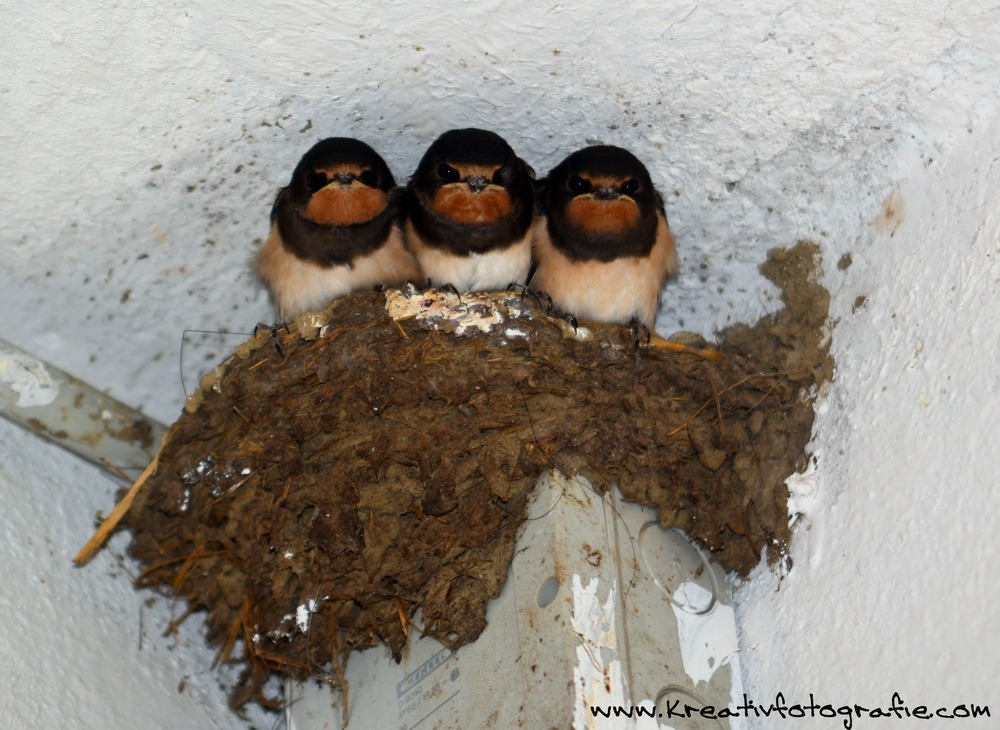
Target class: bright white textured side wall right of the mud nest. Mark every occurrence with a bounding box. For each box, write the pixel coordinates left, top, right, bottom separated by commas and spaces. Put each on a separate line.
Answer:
738, 69, 1000, 727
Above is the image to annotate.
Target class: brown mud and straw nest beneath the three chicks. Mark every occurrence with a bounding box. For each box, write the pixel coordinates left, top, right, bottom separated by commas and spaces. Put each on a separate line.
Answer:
126, 244, 832, 705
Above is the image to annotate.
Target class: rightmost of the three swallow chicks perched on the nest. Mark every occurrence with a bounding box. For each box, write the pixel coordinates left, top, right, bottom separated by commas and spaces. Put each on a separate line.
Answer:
530, 145, 677, 335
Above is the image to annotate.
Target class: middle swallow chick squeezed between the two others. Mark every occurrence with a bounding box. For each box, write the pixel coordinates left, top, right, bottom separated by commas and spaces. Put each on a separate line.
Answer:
406, 129, 535, 292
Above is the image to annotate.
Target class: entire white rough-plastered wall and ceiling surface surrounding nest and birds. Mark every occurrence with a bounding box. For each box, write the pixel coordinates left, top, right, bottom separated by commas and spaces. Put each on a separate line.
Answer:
0, 0, 1000, 728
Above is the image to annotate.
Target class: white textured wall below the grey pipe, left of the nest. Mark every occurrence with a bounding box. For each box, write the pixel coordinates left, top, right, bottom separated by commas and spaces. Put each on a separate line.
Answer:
0, 419, 273, 730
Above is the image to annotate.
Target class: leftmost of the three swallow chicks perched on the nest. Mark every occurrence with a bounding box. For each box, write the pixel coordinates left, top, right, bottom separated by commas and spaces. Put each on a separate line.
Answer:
257, 137, 423, 321
